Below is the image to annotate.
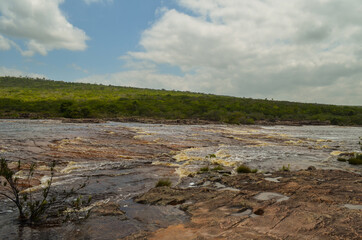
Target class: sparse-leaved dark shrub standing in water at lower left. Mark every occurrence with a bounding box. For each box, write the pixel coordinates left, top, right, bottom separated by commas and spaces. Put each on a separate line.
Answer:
0, 158, 92, 224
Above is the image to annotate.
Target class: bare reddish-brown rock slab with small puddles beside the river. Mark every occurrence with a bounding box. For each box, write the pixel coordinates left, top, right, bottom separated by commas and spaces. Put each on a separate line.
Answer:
134, 170, 362, 239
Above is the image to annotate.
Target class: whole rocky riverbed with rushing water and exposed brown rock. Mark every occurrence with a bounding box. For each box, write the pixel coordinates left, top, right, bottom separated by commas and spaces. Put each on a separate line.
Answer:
0, 120, 362, 239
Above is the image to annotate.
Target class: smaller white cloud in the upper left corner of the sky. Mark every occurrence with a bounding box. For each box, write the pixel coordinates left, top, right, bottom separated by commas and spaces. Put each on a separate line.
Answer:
0, 0, 88, 56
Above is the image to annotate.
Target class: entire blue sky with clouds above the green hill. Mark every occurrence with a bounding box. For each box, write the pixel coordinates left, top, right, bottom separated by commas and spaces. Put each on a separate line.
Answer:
0, 0, 362, 105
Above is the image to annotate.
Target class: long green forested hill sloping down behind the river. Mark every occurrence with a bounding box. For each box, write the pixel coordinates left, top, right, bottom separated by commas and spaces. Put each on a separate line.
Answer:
0, 77, 362, 125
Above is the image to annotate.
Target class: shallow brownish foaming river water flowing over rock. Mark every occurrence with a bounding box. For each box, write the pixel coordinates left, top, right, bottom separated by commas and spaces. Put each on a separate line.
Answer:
0, 120, 362, 239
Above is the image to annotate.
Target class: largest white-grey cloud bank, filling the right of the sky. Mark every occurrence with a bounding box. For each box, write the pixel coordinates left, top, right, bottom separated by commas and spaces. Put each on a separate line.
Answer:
111, 0, 362, 105
